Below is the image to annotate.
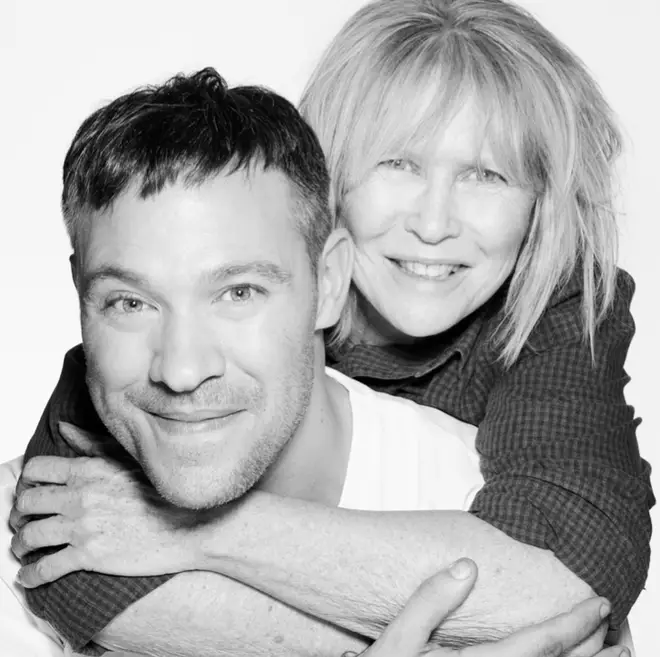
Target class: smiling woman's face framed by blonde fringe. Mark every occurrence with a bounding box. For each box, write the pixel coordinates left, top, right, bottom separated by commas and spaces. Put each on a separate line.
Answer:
343, 103, 535, 342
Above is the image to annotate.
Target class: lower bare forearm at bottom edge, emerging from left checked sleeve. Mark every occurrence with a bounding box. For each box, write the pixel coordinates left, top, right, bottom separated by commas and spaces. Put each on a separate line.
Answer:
94, 572, 367, 657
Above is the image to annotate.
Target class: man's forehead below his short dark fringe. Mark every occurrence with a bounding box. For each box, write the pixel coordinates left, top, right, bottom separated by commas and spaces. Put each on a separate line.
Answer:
81, 169, 306, 278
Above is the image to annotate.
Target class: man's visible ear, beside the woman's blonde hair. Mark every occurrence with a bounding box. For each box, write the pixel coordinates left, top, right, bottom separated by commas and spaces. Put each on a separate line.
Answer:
316, 228, 354, 331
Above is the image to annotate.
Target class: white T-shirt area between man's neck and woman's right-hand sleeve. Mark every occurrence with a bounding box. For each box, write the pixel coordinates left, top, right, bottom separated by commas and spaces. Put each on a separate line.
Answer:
326, 368, 484, 511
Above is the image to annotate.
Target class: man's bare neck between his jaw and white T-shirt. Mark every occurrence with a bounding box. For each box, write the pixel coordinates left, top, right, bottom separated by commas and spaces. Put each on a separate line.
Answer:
256, 364, 353, 506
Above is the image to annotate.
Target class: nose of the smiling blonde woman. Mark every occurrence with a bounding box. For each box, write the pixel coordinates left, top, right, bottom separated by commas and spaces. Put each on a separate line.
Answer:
406, 176, 461, 244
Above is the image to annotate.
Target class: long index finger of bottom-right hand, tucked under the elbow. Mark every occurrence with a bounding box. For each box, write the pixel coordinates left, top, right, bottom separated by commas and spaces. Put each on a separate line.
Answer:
466, 598, 610, 657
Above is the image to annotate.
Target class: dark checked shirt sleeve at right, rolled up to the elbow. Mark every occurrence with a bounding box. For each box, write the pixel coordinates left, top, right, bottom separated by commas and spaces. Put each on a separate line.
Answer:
471, 271, 655, 628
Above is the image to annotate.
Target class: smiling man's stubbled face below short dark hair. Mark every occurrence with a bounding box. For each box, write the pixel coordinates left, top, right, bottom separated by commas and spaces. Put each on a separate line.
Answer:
77, 169, 317, 508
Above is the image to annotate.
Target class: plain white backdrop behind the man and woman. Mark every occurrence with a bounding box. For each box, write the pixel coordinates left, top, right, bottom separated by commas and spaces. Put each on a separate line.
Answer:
0, 0, 660, 657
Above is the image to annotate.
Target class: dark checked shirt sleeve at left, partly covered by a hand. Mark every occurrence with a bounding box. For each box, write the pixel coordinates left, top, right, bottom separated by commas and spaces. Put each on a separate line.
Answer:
23, 346, 172, 655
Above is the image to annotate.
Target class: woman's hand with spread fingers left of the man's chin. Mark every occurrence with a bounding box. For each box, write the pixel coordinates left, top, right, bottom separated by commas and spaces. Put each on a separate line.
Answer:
10, 423, 201, 588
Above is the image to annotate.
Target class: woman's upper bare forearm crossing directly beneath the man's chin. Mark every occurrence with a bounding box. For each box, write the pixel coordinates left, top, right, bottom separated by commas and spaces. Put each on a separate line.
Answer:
199, 491, 593, 645
